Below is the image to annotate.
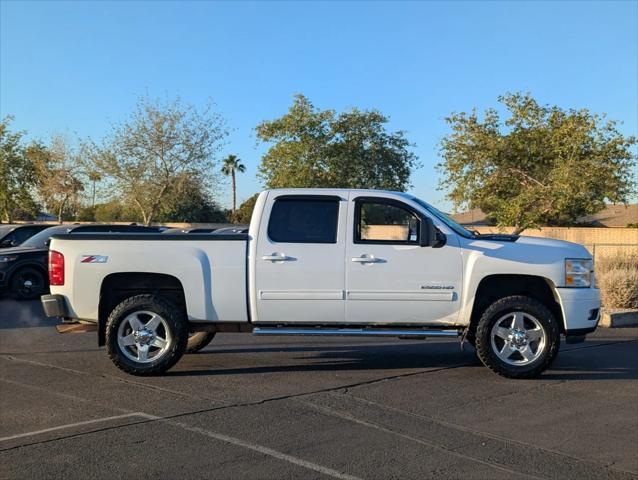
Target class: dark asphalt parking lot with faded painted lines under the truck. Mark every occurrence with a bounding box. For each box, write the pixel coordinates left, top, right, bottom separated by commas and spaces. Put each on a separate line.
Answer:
0, 299, 638, 479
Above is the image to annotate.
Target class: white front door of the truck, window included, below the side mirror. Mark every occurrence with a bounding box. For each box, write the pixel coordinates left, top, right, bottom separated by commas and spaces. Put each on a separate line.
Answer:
346, 194, 462, 325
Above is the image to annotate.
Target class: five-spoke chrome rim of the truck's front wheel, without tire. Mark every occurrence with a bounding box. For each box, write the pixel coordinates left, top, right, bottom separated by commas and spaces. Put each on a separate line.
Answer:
490, 311, 547, 366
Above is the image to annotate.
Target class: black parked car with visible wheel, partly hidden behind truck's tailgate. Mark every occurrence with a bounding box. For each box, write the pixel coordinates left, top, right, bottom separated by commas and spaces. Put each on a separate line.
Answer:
0, 225, 159, 300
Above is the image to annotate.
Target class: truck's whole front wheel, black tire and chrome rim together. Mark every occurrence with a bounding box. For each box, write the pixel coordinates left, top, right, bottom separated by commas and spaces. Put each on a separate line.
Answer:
475, 295, 560, 378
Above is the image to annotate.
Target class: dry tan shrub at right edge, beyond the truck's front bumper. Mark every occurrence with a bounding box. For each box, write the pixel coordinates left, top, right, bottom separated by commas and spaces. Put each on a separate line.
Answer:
596, 253, 638, 308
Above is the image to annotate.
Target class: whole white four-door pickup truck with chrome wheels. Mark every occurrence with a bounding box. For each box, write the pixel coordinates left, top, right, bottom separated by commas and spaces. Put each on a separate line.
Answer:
42, 189, 600, 378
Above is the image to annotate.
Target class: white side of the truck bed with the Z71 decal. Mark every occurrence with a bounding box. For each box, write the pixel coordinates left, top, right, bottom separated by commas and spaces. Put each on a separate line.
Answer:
50, 233, 248, 322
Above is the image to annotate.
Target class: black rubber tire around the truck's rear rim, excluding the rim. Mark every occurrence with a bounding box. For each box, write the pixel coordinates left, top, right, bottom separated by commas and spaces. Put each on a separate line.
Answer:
106, 294, 188, 376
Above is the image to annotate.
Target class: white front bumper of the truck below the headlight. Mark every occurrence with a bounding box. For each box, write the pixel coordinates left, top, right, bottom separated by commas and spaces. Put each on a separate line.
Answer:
556, 288, 600, 336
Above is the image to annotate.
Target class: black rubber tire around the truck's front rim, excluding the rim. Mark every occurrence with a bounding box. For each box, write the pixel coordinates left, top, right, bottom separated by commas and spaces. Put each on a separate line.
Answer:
475, 295, 560, 379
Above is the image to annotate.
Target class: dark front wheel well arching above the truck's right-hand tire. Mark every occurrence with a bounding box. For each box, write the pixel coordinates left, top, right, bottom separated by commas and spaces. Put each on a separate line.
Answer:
469, 275, 564, 335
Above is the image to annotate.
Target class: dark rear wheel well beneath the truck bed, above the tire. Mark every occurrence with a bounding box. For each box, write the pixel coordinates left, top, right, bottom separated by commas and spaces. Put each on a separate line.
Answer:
98, 272, 186, 346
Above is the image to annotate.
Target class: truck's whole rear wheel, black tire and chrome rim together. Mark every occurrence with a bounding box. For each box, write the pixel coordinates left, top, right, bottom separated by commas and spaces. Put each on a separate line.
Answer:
106, 294, 188, 376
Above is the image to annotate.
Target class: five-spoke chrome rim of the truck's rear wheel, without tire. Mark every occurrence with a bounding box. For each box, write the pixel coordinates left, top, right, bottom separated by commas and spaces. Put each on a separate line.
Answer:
117, 310, 172, 363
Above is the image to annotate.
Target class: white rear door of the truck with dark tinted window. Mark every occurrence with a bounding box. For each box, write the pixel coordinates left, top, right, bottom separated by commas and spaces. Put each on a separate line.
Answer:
253, 192, 348, 323
